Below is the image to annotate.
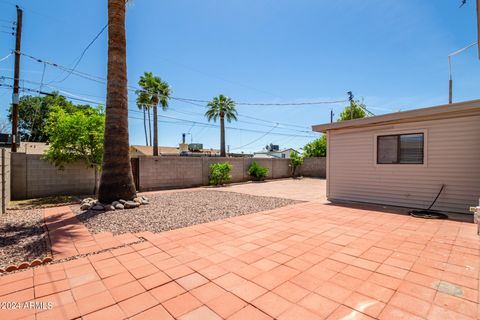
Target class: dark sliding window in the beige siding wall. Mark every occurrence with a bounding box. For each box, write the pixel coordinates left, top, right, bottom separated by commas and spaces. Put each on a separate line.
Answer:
377, 133, 424, 164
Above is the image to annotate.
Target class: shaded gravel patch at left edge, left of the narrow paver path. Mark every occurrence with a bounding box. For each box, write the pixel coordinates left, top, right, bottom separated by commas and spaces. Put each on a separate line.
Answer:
0, 209, 49, 268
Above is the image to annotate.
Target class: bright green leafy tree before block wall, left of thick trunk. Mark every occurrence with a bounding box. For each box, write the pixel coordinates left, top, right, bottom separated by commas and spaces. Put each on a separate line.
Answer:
43, 107, 105, 194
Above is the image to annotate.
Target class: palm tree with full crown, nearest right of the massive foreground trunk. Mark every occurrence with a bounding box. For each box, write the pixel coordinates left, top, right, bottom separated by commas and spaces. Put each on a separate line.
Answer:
138, 72, 172, 156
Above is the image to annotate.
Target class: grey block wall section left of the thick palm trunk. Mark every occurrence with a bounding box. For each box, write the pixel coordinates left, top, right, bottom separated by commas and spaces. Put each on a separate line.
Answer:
11, 153, 95, 200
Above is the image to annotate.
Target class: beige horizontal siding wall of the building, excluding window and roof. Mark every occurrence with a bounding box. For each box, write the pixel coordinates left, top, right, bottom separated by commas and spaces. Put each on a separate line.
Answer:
327, 115, 480, 213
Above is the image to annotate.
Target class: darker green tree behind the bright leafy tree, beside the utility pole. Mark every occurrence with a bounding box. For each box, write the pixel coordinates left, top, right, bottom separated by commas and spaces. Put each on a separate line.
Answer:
8, 92, 90, 142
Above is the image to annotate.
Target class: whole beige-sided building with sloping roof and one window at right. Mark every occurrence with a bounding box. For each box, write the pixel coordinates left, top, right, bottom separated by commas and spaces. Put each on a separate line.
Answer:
313, 100, 480, 213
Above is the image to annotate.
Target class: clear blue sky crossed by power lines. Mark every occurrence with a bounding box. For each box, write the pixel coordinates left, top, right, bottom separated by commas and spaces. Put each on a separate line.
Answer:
0, 0, 480, 152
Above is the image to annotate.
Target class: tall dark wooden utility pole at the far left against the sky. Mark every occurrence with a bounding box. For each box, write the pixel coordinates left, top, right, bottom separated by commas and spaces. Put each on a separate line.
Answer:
12, 6, 23, 152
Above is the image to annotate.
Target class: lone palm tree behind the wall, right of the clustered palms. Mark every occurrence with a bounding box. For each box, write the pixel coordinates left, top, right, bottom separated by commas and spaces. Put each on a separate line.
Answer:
205, 94, 237, 157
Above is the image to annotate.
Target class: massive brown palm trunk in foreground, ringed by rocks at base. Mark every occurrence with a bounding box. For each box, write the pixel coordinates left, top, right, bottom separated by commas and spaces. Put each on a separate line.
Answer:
98, 0, 136, 203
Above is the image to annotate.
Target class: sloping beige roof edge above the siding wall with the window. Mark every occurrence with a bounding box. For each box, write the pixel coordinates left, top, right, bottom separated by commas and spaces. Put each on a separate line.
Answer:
312, 100, 480, 132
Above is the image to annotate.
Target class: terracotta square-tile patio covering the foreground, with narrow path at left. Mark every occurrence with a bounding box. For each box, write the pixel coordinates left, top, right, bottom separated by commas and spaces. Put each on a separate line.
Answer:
0, 202, 480, 320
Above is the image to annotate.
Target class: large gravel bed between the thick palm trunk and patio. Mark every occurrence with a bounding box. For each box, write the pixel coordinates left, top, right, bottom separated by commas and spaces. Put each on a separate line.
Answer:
72, 190, 299, 234
